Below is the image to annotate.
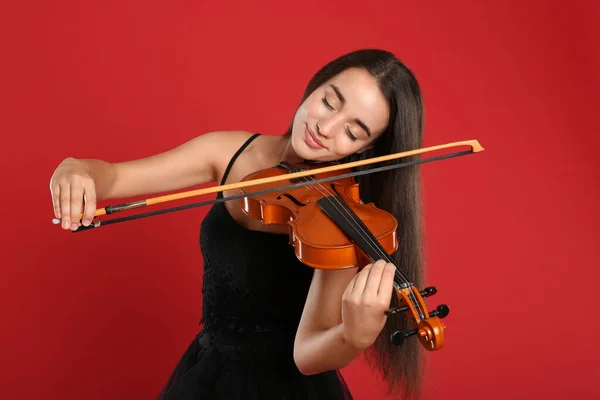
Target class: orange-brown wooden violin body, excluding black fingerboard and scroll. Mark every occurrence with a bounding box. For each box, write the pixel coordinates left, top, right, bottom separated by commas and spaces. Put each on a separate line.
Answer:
241, 164, 398, 269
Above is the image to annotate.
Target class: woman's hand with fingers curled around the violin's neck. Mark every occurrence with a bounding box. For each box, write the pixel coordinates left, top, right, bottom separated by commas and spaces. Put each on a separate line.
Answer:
342, 260, 396, 349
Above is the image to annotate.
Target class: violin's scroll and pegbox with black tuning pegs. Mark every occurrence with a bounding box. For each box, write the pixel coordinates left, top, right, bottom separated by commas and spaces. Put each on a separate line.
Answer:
386, 285, 450, 351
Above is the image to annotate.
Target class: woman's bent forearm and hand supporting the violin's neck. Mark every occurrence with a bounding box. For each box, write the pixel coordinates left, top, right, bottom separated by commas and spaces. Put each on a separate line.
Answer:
294, 260, 395, 375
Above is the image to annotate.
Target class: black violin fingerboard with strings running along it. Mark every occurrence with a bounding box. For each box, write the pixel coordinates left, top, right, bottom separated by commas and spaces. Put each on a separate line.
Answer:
317, 194, 412, 288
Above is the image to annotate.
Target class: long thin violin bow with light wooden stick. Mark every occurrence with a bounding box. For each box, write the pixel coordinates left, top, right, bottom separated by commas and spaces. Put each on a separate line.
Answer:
52, 140, 484, 233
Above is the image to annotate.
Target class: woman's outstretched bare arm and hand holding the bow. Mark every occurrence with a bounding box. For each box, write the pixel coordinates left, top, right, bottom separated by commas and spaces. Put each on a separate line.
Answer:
50, 132, 234, 229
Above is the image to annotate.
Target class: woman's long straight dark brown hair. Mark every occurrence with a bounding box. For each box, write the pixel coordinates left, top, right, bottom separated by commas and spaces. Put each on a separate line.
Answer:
285, 49, 423, 398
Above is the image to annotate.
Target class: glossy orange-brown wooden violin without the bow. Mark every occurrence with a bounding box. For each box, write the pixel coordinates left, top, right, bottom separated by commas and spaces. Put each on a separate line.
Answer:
241, 162, 449, 350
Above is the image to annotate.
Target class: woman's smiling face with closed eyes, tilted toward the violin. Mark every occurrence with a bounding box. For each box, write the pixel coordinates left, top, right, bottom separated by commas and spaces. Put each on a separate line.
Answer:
291, 68, 389, 161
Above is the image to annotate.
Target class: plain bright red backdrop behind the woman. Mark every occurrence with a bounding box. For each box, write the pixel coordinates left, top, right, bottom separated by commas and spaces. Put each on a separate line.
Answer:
0, 0, 600, 399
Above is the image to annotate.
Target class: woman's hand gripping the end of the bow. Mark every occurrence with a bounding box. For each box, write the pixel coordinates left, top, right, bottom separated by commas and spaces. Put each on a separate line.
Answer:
50, 158, 96, 230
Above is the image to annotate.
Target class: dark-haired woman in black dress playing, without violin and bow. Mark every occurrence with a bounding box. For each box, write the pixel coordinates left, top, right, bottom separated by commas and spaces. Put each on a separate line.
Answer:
51, 50, 423, 400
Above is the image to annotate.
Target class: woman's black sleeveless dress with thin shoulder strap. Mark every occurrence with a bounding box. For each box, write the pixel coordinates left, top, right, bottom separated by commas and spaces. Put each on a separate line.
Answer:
158, 135, 351, 400
